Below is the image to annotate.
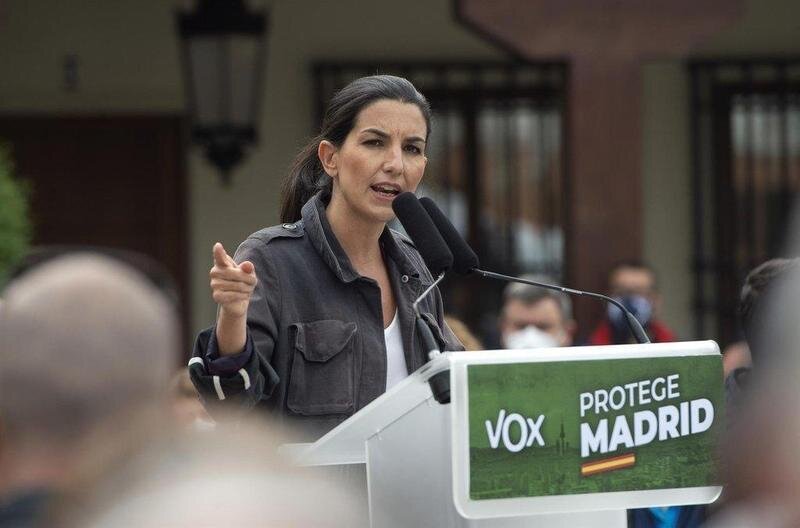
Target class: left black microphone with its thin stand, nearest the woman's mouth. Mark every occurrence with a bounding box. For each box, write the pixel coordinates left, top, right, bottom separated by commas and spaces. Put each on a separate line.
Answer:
392, 192, 453, 404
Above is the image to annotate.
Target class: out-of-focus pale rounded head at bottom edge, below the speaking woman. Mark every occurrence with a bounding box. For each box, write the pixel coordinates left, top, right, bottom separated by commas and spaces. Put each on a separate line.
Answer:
57, 416, 367, 528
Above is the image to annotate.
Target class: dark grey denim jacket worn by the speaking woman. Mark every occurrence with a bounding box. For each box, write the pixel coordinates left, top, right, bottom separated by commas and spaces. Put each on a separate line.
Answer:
190, 195, 463, 440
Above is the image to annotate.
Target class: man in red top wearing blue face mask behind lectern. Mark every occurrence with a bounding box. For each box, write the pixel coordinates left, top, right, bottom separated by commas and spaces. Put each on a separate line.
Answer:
587, 260, 676, 345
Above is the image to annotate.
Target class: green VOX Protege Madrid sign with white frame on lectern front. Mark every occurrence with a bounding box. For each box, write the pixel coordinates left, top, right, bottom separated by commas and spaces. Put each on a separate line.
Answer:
453, 343, 724, 512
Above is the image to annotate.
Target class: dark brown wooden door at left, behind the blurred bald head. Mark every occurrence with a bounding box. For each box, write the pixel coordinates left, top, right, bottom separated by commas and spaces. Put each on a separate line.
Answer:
0, 116, 189, 344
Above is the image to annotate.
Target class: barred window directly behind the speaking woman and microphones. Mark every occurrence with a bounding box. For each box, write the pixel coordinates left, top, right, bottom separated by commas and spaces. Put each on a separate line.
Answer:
314, 62, 567, 347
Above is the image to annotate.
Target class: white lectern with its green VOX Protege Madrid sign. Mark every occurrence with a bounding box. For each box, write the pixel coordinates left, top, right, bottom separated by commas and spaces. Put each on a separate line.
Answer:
284, 341, 725, 528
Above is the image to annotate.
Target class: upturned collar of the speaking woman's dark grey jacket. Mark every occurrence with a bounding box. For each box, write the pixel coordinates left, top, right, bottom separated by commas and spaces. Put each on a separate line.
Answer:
300, 192, 419, 282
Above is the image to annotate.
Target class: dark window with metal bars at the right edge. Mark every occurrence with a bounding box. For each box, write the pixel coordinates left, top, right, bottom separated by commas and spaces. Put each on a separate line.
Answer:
689, 59, 800, 346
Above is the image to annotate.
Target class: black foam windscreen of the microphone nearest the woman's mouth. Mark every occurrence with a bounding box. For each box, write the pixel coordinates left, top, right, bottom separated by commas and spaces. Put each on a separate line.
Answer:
392, 192, 453, 277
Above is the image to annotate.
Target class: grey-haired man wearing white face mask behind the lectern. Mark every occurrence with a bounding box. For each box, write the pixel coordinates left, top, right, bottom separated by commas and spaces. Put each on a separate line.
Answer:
500, 275, 575, 348
